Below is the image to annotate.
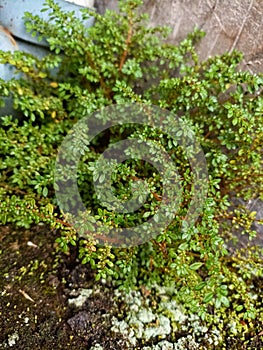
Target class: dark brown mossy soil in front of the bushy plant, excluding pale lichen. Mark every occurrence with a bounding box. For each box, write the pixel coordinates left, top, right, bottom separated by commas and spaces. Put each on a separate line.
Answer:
0, 225, 263, 350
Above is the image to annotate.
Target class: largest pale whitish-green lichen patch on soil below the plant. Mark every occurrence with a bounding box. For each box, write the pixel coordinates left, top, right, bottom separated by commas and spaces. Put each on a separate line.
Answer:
111, 288, 222, 350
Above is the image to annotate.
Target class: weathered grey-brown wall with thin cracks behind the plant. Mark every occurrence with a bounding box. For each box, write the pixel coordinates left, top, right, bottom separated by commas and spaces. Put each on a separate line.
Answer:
95, 0, 263, 72
